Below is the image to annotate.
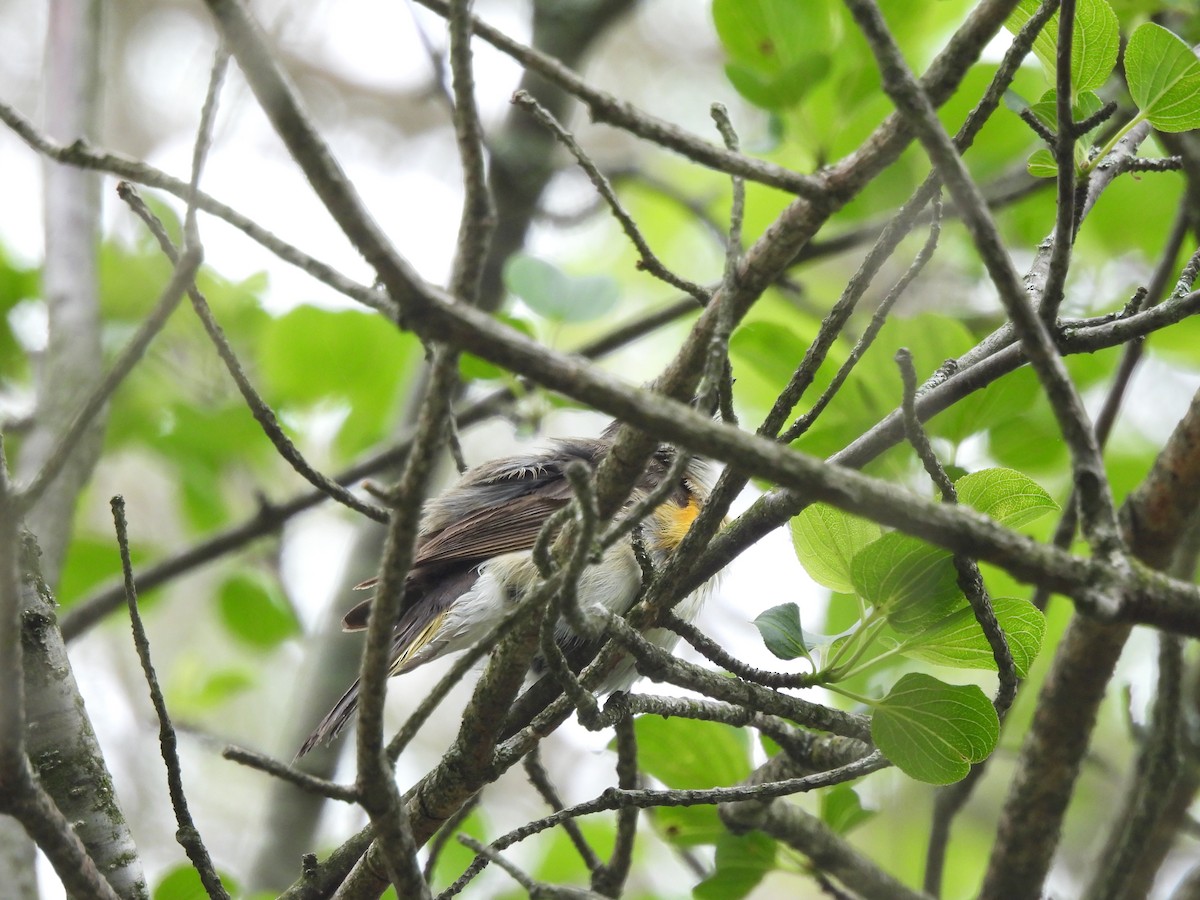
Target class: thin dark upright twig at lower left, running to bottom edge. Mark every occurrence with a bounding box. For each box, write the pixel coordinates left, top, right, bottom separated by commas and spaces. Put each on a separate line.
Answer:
110, 496, 229, 900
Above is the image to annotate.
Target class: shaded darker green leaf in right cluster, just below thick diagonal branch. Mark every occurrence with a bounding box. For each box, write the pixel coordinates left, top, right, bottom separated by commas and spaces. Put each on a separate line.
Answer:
851, 532, 966, 632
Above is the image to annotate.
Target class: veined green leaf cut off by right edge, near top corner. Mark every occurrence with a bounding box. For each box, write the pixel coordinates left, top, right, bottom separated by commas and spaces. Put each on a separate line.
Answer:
1124, 22, 1200, 132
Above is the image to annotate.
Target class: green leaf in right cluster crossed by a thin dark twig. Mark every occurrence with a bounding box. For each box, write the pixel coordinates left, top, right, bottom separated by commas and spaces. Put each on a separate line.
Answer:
900, 596, 1046, 678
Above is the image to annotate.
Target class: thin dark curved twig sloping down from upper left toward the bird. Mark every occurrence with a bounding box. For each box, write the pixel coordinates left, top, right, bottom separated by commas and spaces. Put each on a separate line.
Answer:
116, 181, 388, 523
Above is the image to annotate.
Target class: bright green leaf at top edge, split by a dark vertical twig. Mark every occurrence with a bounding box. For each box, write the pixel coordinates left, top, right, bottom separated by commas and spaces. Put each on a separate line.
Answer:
1004, 0, 1120, 94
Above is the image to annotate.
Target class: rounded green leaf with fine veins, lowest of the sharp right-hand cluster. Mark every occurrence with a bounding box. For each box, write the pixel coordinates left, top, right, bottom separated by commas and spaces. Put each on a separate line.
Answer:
871, 672, 1000, 785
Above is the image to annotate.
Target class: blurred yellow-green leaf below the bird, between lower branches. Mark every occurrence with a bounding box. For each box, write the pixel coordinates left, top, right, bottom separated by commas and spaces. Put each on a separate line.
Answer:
634, 715, 750, 791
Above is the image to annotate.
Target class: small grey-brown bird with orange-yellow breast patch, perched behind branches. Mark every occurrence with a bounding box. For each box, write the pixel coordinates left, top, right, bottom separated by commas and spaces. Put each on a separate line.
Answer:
298, 424, 712, 756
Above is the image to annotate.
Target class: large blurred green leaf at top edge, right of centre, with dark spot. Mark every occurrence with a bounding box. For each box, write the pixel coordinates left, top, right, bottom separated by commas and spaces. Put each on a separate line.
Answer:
713, 0, 832, 112
